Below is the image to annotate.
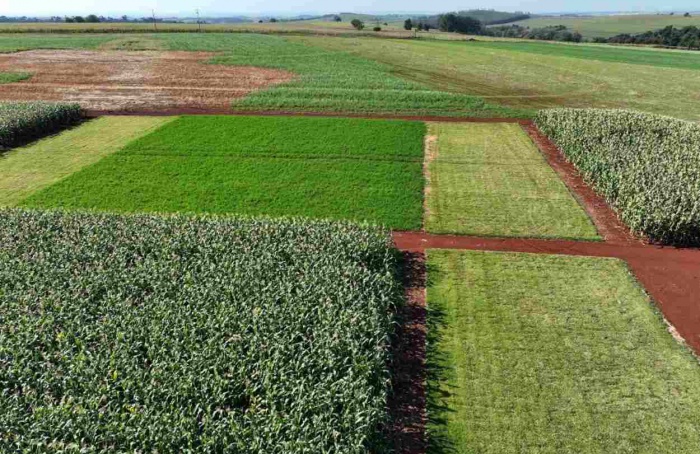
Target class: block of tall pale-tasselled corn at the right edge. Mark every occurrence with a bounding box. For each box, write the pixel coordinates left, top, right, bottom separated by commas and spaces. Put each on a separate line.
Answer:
536, 109, 700, 245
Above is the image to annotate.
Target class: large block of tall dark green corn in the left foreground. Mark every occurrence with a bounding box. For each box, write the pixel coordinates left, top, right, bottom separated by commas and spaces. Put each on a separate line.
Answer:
0, 211, 401, 454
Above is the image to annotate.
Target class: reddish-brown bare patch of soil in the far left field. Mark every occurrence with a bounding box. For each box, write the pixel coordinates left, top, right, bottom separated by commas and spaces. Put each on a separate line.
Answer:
0, 50, 295, 112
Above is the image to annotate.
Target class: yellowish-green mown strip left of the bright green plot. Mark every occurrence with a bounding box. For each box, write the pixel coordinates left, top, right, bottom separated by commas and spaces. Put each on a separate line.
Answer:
0, 117, 172, 206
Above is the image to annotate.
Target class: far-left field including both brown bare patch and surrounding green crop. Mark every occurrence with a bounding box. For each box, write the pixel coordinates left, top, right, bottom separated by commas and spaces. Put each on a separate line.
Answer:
0, 33, 532, 117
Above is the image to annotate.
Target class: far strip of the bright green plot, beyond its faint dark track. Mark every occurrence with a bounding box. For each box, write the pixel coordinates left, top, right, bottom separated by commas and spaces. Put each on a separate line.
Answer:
125, 116, 425, 162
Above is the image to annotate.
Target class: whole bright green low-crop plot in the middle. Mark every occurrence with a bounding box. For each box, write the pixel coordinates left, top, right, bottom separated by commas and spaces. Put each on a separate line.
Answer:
23, 117, 425, 230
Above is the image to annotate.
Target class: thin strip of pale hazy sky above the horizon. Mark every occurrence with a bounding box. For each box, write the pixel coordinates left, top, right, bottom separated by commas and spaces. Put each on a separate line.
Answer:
0, 0, 700, 16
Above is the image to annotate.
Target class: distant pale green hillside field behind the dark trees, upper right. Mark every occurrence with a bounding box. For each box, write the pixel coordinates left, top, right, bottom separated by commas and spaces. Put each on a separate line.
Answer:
515, 13, 700, 38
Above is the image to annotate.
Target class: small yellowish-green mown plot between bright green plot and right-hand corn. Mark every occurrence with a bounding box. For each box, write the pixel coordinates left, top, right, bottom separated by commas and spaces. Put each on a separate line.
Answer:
425, 123, 600, 239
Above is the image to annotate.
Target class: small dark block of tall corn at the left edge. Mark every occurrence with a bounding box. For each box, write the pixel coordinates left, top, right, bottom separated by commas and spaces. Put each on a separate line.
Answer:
0, 102, 83, 149
